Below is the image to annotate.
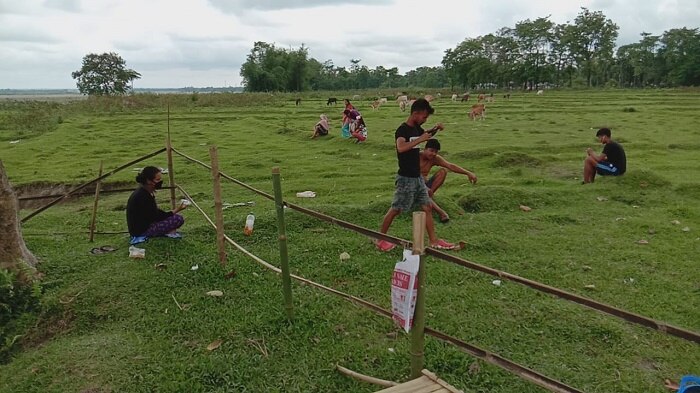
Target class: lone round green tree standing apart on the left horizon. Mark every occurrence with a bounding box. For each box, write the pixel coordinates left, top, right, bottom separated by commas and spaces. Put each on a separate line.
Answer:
71, 52, 141, 96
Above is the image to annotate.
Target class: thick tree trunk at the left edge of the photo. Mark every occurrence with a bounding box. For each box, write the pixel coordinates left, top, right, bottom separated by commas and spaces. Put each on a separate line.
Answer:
0, 160, 37, 282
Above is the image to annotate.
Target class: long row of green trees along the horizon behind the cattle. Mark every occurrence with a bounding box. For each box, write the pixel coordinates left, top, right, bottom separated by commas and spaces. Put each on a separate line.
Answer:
240, 7, 700, 92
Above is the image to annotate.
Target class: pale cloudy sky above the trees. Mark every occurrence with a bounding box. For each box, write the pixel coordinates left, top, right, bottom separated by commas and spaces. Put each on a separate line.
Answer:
0, 0, 700, 89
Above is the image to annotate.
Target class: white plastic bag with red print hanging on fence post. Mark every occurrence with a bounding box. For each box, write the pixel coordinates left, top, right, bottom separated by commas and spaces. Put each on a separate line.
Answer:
391, 250, 420, 333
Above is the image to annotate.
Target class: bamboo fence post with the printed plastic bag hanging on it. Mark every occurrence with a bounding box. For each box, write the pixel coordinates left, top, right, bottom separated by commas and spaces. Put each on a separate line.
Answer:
411, 212, 426, 379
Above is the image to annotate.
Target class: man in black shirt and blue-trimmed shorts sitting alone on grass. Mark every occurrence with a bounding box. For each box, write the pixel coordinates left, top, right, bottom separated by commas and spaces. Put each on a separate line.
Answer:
583, 128, 627, 184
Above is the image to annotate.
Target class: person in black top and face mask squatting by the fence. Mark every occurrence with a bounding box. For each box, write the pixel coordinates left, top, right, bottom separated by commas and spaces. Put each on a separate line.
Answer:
126, 166, 186, 244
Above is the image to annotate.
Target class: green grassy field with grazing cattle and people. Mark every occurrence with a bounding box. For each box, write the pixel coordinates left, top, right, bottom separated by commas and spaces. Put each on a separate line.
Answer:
0, 90, 700, 393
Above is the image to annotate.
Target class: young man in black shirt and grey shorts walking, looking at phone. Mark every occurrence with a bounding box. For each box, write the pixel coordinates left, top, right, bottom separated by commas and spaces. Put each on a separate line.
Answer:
376, 98, 455, 251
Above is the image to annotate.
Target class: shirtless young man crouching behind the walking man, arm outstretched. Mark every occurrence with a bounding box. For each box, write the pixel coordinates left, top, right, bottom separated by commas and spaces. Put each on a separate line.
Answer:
420, 138, 476, 223
